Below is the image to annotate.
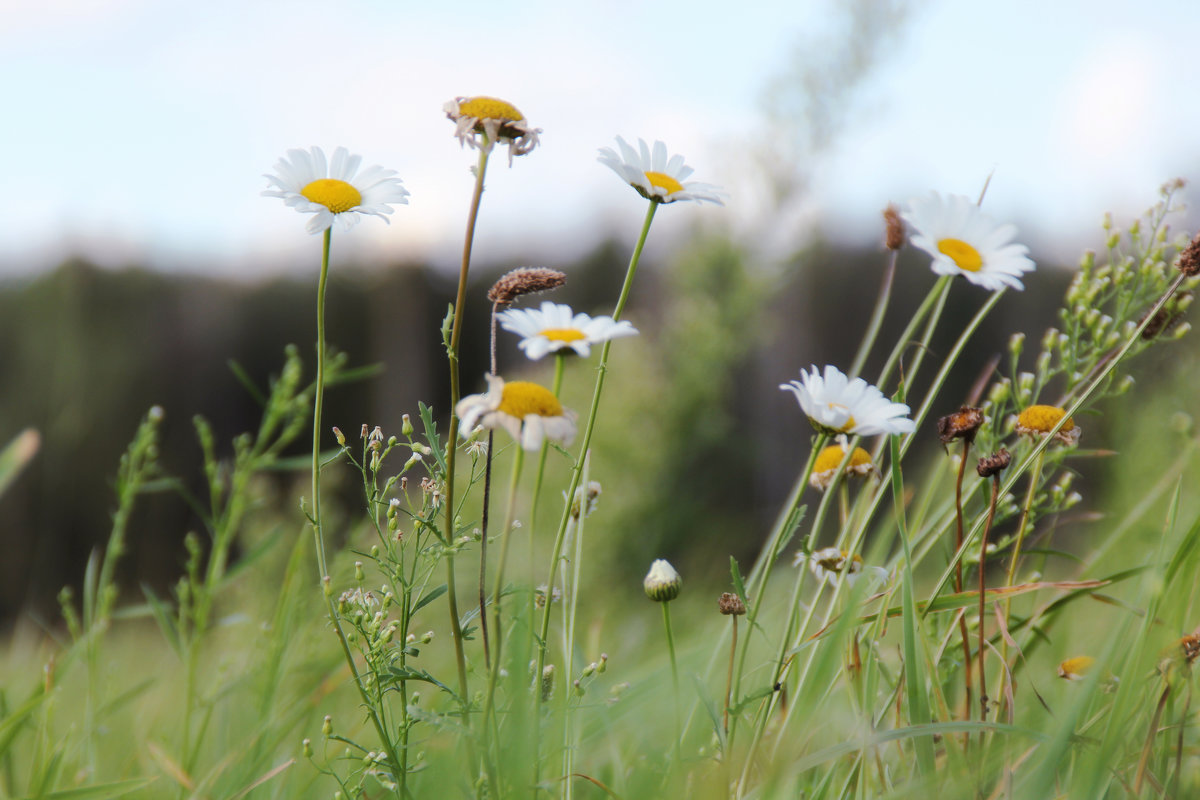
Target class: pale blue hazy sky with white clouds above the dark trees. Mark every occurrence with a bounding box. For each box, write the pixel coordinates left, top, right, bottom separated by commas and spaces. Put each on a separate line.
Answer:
0, 0, 1200, 275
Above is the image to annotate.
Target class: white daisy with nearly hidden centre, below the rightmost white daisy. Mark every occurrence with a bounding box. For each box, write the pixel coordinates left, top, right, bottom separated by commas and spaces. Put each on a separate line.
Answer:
779, 366, 917, 437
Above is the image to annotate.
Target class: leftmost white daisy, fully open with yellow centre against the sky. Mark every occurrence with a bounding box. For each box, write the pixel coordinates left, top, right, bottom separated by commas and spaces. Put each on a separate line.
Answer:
263, 148, 408, 234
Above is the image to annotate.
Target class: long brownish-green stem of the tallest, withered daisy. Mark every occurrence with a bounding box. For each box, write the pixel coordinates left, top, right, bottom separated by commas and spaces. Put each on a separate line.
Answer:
444, 136, 490, 729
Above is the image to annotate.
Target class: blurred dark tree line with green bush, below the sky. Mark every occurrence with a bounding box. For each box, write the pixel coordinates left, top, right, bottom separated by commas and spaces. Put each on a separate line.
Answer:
0, 234, 1069, 621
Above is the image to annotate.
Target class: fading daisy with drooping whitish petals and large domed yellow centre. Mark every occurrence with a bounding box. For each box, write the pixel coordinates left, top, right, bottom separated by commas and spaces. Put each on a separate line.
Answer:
455, 375, 575, 451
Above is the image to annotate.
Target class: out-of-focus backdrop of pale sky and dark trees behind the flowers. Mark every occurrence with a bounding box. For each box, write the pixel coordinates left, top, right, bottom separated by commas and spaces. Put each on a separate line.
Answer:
0, 0, 1200, 624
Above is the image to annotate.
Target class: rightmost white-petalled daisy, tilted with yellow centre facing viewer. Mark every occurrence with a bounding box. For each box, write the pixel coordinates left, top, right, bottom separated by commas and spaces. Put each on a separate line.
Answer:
901, 192, 1034, 290
